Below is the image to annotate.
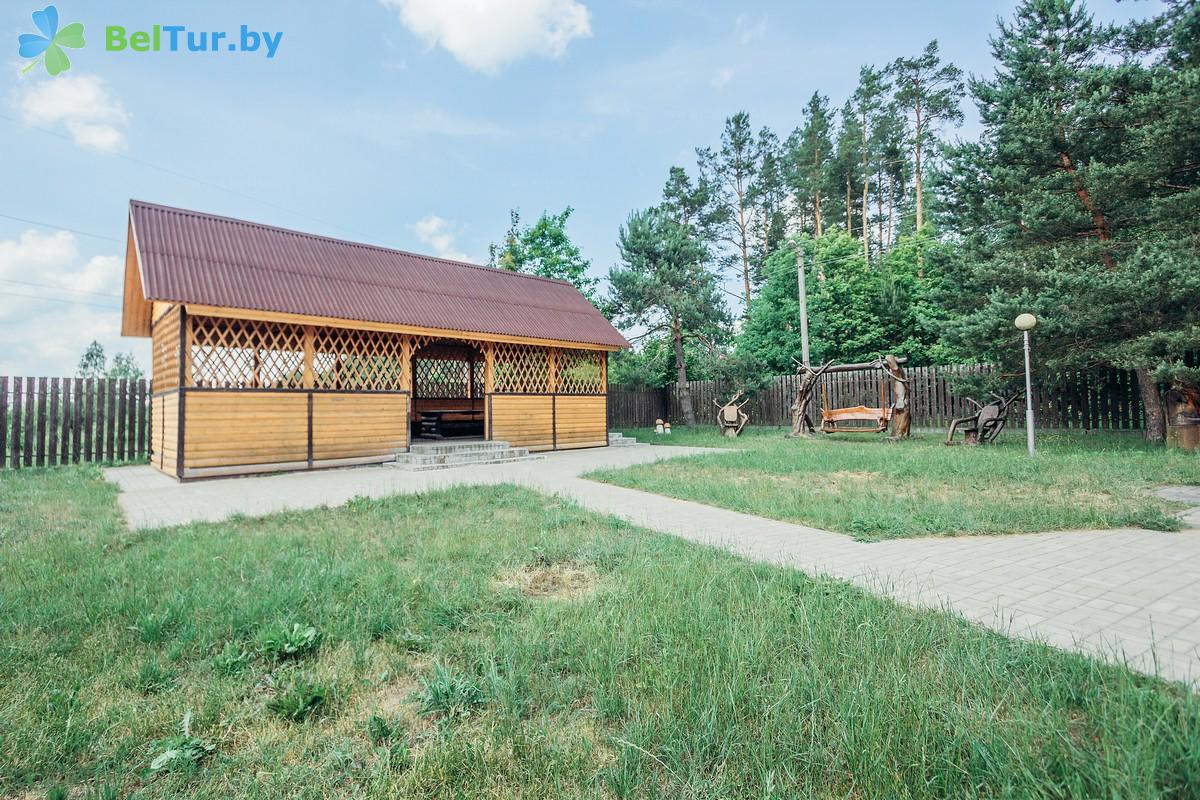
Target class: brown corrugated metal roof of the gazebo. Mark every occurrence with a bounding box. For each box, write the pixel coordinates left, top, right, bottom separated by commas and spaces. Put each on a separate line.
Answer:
130, 200, 629, 347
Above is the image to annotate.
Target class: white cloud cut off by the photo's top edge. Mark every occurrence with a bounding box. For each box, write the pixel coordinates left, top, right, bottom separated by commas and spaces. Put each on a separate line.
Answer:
380, 0, 592, 74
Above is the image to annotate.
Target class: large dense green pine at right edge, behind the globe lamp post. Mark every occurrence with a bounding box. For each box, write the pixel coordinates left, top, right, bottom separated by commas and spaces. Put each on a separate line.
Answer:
946, 0, 1200, 440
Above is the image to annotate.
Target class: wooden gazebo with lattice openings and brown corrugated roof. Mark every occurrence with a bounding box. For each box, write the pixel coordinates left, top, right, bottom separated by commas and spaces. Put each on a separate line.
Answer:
121, 201, 629, 480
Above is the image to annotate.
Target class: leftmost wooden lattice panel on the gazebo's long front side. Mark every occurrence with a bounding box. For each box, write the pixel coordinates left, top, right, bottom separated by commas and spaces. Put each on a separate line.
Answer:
188, 317, 304, 389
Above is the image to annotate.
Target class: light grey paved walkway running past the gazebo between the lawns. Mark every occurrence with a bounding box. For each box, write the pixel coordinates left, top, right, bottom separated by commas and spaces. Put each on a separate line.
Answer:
106, 445, 1200, 686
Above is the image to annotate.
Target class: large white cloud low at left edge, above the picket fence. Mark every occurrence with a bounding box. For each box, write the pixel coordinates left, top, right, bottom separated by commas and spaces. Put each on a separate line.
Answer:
0, 230, 150, 377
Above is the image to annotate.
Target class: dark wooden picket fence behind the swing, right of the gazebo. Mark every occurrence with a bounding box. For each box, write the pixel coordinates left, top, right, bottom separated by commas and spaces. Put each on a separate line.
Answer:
608, 365, 1142, 431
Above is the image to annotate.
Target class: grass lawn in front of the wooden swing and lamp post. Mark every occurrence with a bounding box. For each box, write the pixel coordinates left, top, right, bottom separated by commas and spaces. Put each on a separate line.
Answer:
587, 426, 1200, 541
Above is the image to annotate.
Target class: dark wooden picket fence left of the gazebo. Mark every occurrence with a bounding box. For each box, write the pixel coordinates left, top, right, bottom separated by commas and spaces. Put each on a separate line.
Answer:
0, 375, 150, 469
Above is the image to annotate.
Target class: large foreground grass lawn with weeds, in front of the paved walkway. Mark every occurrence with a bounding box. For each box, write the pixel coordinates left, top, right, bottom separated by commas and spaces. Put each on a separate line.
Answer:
0, 465, 1200, 799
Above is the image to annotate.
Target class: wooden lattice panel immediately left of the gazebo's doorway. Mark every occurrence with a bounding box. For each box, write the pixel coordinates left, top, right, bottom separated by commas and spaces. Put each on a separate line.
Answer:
312, 327, 408, 391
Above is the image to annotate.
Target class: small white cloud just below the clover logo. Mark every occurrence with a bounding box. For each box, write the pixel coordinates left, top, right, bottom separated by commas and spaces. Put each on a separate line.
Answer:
17, 74, 130, 152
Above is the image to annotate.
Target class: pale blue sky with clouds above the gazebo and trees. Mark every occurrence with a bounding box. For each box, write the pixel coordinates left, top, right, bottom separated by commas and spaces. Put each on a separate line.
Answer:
0, 0, 1157, 375
